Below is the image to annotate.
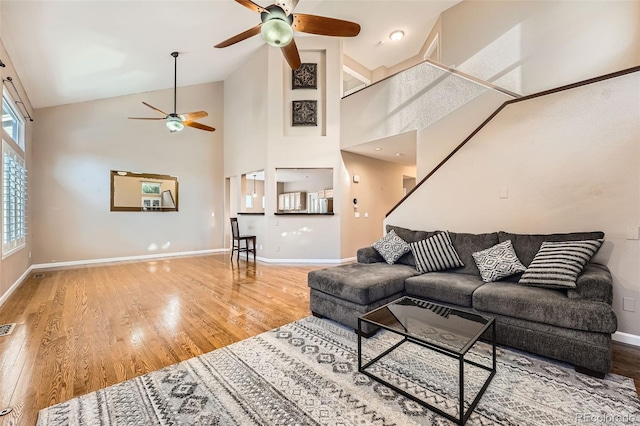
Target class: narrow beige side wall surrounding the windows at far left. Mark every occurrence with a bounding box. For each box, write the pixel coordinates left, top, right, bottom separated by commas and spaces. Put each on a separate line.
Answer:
0, 38, 37, 305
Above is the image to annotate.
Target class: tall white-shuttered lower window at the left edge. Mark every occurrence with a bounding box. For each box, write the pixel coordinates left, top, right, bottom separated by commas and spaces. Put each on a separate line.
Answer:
2, 141, 27, 256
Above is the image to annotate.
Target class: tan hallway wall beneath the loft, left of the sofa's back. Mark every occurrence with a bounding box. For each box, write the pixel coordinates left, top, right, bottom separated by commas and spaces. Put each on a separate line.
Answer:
340, 151, 407, 259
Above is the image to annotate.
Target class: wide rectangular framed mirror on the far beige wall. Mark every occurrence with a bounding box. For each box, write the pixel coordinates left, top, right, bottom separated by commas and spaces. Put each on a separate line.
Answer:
111, 170, 178, 212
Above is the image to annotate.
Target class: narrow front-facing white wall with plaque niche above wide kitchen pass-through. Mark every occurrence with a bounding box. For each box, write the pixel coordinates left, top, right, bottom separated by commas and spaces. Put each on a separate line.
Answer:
266, 37, 342, 260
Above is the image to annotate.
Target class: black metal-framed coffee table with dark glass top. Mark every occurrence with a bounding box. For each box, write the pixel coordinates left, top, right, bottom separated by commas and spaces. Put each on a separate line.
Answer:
358, 296, 496, 425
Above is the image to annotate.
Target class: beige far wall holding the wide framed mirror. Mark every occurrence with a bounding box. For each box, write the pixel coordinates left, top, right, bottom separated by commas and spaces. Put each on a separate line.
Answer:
30, 82, 224, 264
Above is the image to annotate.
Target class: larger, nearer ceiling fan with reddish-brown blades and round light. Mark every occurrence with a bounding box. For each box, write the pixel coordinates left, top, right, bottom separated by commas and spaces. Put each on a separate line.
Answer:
215, 0, 360, 70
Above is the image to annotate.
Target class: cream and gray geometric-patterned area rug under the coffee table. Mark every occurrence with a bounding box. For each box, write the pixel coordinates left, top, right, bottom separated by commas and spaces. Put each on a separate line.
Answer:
38, 317, 640, 426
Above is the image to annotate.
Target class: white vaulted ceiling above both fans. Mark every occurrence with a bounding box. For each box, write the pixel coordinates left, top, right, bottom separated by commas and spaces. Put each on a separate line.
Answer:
0, 0, 459, 108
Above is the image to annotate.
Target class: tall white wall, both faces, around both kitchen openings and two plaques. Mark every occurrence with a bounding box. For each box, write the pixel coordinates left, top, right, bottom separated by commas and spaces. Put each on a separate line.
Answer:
224, 37, 342, 261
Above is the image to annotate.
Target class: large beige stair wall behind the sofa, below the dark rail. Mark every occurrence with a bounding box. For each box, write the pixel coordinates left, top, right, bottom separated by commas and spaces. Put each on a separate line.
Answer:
385, 73, 640, 335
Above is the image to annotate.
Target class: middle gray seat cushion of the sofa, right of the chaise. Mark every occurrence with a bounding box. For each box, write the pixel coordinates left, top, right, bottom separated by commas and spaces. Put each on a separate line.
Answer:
405, 272, 482, 307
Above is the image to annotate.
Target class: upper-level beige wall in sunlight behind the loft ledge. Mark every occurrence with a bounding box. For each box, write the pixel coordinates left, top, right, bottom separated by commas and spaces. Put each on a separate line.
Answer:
441, 0, 640, 95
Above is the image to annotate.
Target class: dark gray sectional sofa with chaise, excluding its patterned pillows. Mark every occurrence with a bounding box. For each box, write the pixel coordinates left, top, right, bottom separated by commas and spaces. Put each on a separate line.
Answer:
308, 225, 617, 376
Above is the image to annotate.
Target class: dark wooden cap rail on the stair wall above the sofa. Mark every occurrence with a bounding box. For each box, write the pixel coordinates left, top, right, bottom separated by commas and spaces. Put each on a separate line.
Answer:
385, 66, 640, 217
